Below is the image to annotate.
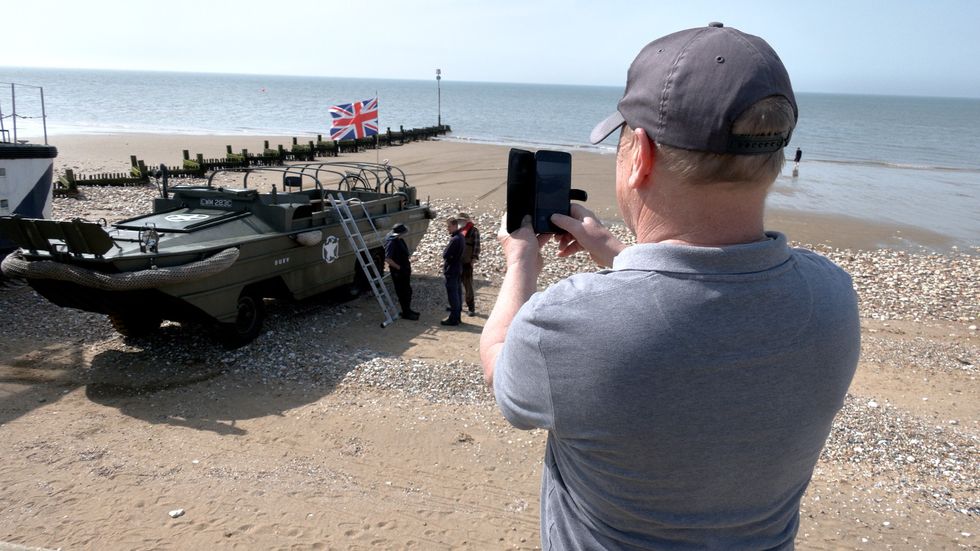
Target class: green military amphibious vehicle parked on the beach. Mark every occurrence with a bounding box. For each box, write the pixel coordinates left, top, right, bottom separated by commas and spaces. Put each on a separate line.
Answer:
0, 162, 433, 346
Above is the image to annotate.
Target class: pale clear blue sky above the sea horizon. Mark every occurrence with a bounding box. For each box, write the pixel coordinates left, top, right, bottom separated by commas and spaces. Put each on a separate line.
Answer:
0, 0, 980, 97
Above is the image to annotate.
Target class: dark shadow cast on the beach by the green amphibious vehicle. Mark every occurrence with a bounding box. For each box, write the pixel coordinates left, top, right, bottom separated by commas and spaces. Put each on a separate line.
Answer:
79, 276, 460, 435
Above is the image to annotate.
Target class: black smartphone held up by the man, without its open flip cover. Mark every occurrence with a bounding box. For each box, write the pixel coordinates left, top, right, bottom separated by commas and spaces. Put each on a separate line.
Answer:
531, 150, 572, 233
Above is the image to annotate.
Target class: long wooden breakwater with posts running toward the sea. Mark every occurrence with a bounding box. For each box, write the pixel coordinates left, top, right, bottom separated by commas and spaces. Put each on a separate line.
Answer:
53, 124, 452, 196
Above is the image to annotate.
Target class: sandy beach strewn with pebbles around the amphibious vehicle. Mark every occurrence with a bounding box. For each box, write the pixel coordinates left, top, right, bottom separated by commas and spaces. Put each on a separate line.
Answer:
0, 135, 980, 550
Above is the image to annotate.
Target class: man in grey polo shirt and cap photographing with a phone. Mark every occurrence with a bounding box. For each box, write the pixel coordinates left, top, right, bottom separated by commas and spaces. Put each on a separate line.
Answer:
480, 23, 860, 549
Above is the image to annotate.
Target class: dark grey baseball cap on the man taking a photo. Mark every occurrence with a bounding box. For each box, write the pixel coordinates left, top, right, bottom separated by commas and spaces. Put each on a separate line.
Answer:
590, 23, 799, 155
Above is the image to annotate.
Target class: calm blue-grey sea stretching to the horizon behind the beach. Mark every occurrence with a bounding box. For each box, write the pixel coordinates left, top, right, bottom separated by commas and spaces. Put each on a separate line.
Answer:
0, 68, 980, 246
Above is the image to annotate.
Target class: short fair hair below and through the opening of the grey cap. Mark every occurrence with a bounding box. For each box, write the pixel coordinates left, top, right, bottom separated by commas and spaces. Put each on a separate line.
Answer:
654, 96, 796, 186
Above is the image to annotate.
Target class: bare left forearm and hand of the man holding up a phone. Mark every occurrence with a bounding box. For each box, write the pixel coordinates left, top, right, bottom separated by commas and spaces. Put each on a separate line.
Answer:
480, 216, 551, 386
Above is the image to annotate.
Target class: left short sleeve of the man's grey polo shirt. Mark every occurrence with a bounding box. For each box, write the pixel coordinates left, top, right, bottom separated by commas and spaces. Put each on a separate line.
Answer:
493, 293, 555, 430
